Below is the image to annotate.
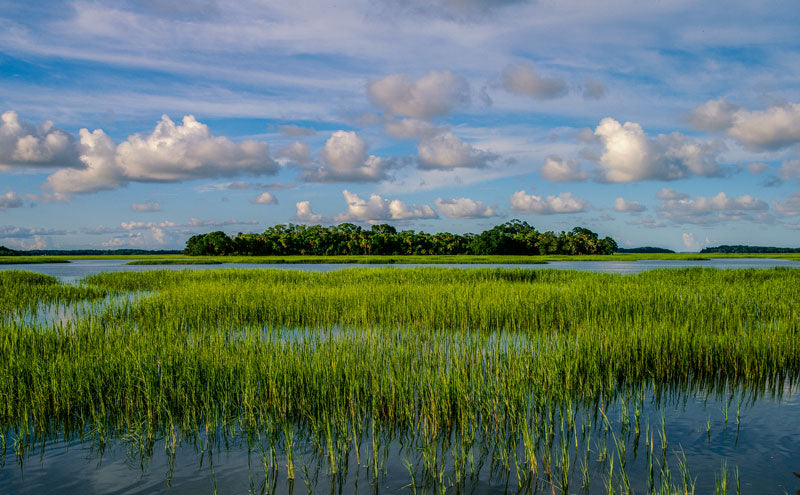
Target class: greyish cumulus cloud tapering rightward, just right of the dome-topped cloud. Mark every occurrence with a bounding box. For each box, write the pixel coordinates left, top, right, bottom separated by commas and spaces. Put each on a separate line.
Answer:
417, 132, 497, 169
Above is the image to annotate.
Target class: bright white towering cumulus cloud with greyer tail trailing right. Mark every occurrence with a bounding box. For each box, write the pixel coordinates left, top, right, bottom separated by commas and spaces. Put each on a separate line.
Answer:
594, 117, 721, 182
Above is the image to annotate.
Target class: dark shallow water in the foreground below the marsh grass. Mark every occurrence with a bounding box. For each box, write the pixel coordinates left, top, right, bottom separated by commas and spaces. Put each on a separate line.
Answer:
0, 386, 800, 494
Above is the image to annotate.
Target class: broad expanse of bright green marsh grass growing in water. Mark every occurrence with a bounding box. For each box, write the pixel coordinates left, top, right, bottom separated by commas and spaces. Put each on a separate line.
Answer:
0, 268, 800, 493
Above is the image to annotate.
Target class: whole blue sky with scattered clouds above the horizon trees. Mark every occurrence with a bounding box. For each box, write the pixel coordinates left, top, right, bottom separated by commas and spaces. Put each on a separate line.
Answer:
0, 0, 800, 251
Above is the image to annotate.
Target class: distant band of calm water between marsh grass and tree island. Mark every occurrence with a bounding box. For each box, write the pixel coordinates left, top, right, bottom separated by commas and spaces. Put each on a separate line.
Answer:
0, 258, 800, 282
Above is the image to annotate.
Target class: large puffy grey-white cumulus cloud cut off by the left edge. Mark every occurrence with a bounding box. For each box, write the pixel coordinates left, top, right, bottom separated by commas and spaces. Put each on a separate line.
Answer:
0, 110, 82, 169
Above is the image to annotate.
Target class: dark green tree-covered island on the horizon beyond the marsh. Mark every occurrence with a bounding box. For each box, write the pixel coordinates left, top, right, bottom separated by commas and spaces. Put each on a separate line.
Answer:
184, 220, 617, 256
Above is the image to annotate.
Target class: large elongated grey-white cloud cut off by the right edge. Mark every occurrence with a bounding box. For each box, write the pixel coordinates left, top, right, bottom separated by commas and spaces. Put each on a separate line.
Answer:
690, 99, 800, 151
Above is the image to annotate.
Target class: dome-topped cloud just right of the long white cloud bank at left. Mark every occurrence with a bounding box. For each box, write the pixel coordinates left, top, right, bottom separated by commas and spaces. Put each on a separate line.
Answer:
302, 131, 390, 182
